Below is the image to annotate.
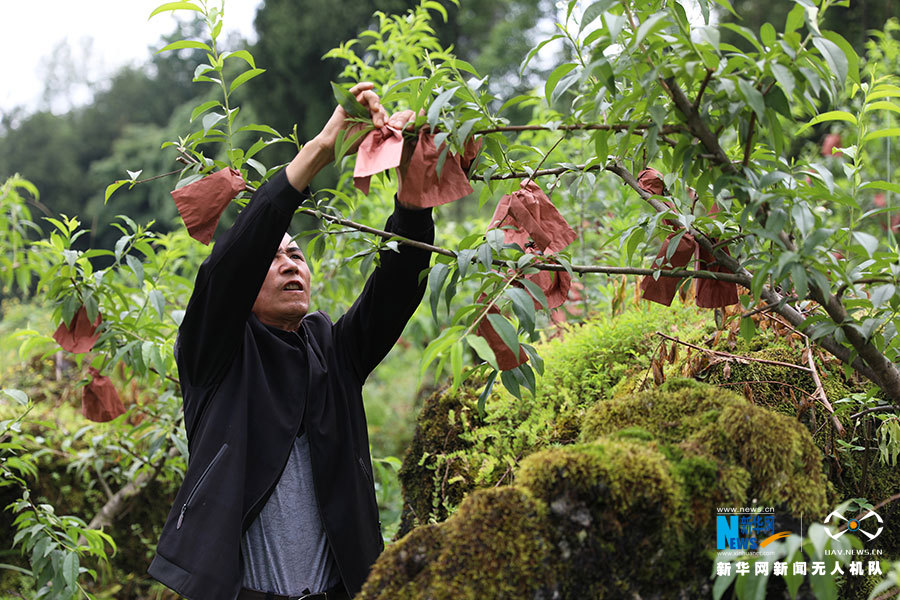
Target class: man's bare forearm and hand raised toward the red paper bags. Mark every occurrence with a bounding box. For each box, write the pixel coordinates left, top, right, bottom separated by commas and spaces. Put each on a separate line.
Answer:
285, 82, 387, 190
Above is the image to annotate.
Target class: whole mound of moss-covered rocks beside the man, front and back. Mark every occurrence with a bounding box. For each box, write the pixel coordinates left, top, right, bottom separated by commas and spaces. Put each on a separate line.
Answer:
382, 309, 900, 600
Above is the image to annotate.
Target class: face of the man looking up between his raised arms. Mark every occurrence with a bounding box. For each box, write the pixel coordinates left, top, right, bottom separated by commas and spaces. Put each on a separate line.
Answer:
253, 234, 309, 331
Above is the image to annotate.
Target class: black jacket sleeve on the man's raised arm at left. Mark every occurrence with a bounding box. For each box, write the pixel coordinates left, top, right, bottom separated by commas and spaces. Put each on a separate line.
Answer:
176, 170, 308, 385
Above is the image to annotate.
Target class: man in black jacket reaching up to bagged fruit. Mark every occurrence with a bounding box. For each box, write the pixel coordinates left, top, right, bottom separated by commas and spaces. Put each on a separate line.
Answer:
149, 84, 434, 600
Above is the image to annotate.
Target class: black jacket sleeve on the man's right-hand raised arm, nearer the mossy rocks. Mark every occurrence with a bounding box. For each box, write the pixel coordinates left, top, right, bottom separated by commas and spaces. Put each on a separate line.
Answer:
334, 204, 434, 383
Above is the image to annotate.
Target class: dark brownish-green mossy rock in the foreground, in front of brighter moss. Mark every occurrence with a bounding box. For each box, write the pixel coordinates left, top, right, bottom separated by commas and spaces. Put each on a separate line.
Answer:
370, 383, 826, 600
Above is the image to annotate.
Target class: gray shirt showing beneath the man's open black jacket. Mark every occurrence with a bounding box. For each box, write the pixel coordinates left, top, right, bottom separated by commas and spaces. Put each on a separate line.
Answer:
241, 433, 340, 596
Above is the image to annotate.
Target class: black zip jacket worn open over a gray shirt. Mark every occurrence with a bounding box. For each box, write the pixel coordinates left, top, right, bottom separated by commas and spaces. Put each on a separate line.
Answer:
149, 171, 434, 600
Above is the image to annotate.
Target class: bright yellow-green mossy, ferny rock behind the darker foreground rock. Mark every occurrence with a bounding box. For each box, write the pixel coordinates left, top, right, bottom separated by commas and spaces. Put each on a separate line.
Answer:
398, 306, 708, 536
